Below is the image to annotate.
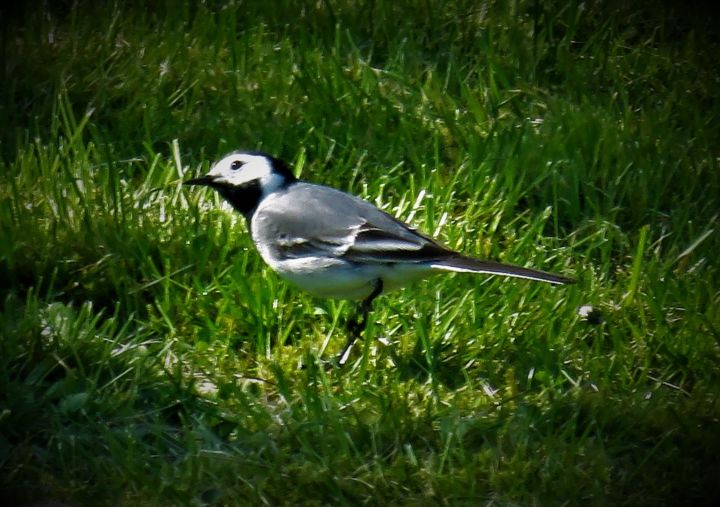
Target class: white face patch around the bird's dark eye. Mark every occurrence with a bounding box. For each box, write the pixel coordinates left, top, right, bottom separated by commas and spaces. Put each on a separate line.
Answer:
208, 153, 285, 197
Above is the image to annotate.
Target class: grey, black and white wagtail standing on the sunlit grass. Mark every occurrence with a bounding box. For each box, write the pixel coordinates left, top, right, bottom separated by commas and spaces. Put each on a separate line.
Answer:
184, 151, 575, 365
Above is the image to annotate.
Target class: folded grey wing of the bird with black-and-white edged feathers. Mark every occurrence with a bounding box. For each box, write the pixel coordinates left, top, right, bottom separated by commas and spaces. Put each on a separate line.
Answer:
253, 182, 454, 264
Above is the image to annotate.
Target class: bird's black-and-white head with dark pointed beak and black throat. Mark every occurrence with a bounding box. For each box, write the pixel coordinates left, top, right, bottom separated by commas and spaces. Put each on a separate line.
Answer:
184, 151, 296, 216
